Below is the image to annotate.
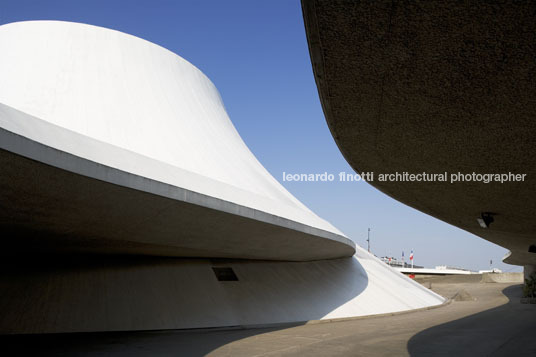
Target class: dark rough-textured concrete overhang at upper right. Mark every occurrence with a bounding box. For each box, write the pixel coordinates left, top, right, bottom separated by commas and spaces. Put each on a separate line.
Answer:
302, 0, 536, 265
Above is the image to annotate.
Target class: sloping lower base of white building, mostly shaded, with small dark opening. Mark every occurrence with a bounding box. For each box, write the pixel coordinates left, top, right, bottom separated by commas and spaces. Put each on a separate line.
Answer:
0, 248, 444, 333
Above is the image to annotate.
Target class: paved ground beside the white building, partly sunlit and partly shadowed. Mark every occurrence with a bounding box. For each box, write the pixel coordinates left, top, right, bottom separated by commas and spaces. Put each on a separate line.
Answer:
0, 279, 536, 356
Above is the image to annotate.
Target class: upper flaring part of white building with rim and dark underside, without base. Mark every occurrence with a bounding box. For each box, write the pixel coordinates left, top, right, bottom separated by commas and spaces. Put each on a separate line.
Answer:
0, 21, 354, 260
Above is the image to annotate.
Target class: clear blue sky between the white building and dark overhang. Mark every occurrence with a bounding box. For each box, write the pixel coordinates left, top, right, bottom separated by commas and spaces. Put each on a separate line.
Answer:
0, 0, 520, 271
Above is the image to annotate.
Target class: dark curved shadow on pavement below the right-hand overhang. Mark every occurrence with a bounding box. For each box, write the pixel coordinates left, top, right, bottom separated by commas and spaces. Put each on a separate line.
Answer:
407, 285, 536, 356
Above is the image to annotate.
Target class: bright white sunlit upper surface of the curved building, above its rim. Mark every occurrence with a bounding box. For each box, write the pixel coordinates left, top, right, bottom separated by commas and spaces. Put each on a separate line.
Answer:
0, 21, 344, 236
